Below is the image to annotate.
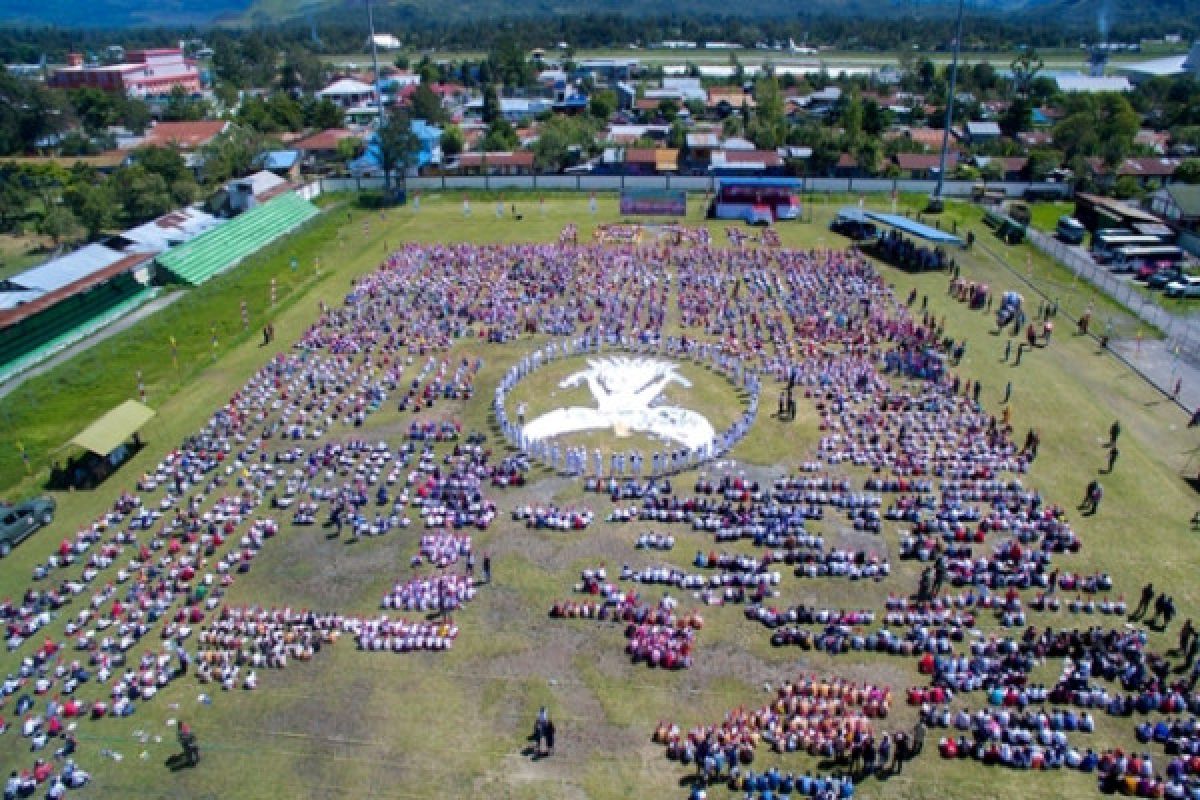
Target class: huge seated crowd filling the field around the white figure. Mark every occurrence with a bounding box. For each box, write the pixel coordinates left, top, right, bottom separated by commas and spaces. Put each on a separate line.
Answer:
0, 220, 1200, 796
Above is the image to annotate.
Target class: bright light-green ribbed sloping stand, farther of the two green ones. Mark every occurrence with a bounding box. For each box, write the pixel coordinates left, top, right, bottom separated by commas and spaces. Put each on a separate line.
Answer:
157, 192, 318, 285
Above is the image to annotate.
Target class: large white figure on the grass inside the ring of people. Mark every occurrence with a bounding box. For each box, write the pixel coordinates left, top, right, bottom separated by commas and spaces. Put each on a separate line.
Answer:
523, 356, 716, 450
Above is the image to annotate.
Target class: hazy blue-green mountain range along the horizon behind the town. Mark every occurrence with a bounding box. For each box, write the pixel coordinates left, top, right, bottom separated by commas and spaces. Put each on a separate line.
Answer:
0, 0, 1180, 28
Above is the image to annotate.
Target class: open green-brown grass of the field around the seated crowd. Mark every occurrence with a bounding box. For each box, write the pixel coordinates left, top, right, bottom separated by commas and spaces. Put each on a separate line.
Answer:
0, 193, 1200, 800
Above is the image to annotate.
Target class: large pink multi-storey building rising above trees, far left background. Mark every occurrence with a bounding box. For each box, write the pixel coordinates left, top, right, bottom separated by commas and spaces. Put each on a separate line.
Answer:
48, 48, 200, 97
